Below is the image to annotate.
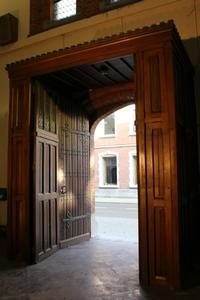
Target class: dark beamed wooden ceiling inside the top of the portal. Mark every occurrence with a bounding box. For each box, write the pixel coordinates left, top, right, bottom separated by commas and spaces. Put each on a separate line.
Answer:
37, 55, 135, 92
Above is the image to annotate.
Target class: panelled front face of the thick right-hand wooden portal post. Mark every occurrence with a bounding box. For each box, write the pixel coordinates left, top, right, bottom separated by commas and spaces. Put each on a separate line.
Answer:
136, 44, 180, 286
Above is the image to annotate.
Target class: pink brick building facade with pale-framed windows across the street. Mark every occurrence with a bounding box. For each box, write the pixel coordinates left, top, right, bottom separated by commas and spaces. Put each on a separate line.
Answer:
94, 104, 137, 202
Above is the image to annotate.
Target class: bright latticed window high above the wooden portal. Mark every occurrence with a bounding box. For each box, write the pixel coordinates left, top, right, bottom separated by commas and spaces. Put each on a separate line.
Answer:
54, 0, 76, 20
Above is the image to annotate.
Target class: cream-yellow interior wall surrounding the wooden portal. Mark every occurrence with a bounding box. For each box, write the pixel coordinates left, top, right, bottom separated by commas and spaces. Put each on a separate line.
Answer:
0, 0, 200, 224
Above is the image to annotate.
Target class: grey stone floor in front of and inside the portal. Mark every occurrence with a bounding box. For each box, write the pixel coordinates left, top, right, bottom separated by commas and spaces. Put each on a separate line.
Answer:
0, 238, 200, 300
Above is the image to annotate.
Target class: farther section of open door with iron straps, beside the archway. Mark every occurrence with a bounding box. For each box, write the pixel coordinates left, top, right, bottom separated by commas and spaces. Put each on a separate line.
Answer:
59, 96, 91, 247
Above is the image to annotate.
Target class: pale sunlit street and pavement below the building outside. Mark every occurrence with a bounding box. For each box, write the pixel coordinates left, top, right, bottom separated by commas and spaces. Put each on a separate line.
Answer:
92, 202, 138, 243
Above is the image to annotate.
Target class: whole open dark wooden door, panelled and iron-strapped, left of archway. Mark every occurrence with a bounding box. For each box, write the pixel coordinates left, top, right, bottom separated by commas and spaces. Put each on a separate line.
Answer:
32, 81, 91, 261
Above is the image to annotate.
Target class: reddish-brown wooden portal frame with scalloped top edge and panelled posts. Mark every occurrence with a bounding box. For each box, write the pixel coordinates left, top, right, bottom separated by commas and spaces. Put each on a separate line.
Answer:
7, 22, 197, 288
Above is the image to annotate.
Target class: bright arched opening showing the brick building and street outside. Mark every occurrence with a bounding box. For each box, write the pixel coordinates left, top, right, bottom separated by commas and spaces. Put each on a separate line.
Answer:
91, 104, 138, 245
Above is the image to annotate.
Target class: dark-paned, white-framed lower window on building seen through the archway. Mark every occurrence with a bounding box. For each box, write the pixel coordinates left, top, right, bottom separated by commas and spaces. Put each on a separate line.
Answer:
103, 156, 117, 185
